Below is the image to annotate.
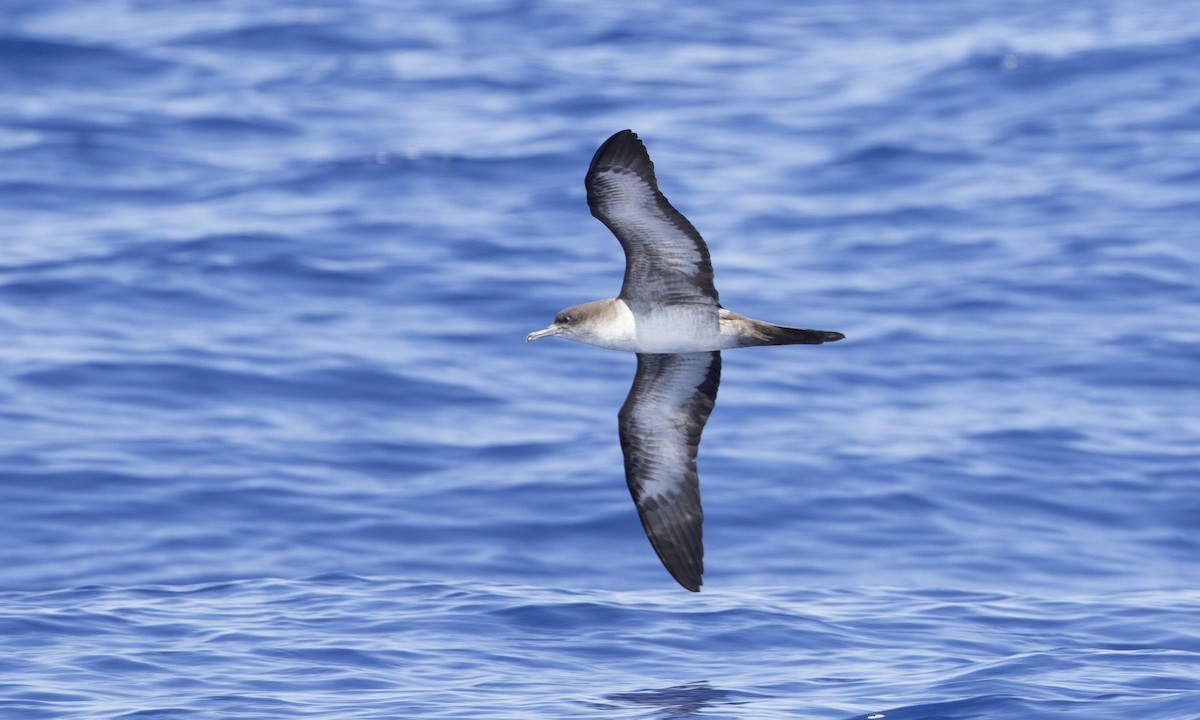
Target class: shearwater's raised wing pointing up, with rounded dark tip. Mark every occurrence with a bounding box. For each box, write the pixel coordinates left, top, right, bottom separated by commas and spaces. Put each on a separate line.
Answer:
584, 130, 719, 305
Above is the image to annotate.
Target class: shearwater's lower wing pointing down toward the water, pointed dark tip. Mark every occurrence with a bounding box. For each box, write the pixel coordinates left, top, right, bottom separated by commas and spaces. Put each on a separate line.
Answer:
618, 352, 721, 593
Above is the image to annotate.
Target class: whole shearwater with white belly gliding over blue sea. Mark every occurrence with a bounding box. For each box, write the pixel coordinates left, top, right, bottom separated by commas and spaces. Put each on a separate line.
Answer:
526, 130, 845, 592
